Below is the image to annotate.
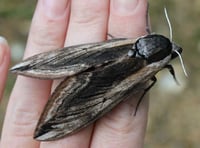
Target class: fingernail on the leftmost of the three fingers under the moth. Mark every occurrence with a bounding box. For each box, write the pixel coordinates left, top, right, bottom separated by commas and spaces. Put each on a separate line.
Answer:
43, 0, 69, 17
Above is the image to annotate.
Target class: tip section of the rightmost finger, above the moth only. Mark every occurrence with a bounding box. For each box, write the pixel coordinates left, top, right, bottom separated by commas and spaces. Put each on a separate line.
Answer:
108, 0, 147, 38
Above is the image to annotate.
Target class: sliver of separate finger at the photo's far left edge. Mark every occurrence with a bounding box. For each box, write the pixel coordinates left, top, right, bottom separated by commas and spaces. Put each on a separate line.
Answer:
0, 37, 10, 99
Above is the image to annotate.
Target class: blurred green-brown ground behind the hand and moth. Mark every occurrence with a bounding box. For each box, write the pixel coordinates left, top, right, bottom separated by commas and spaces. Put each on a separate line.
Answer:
0, 0, 200, 148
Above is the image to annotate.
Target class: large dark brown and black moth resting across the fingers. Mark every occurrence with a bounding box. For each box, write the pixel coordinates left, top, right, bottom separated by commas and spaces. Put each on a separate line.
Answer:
11, 8, 185, 141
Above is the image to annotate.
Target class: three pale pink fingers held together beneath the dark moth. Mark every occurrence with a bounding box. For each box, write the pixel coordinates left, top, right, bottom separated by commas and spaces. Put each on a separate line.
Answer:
0, 0, 148, 148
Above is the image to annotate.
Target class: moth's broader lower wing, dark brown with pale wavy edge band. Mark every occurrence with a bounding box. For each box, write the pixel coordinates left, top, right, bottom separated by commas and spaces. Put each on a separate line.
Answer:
32, 58, 143, 141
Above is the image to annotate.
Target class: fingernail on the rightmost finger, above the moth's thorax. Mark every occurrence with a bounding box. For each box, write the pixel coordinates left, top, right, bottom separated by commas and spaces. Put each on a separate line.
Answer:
113, 0, 139, 14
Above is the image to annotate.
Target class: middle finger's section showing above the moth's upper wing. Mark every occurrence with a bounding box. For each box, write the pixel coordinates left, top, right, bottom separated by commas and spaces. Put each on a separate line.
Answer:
65, 0, 109, 46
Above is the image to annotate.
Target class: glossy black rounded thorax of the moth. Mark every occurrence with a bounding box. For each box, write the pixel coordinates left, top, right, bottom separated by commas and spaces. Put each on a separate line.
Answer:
134, 34, 173, 63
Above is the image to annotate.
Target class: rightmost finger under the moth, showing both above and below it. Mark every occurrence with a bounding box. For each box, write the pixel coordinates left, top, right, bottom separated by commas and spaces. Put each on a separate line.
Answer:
91, 0, 148, 148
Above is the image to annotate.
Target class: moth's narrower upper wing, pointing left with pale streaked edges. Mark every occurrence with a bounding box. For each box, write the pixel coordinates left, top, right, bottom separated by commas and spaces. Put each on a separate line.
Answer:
11, 39, 135, 79
